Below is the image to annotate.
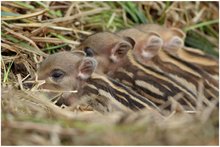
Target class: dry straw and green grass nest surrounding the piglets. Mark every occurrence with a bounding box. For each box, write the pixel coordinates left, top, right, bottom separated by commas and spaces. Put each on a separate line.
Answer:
1, 1, 219, 145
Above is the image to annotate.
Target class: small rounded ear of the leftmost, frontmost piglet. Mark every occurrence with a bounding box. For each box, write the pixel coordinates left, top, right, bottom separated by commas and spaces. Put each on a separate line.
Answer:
77, 57, 97, 80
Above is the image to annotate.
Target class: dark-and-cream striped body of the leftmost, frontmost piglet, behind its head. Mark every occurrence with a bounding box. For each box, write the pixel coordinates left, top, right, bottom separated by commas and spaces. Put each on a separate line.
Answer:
81, 74, 160, 111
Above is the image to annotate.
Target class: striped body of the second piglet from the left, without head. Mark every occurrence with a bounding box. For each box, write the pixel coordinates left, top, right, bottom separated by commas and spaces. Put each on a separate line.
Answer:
98, 51, 196, 110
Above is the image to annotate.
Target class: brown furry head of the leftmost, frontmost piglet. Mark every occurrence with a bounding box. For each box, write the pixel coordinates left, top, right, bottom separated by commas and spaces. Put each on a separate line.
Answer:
37, 52, 96, 105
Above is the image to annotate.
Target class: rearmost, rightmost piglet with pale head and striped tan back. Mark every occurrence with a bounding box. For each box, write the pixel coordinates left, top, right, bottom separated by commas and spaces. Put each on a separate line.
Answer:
136, 24, 219, 76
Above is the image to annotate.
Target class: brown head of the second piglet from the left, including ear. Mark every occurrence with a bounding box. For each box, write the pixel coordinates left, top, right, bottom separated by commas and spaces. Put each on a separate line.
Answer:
79, 32, 134, 74
